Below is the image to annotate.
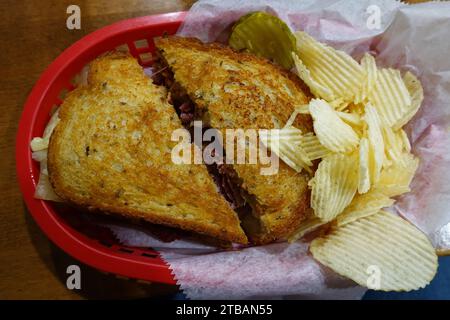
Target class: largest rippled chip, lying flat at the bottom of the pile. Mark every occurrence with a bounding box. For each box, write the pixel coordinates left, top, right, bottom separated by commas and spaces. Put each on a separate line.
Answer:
310, 211, 438, 291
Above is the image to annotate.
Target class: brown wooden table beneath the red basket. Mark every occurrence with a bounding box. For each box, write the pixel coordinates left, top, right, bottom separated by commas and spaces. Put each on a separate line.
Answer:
0, 0, 430, 299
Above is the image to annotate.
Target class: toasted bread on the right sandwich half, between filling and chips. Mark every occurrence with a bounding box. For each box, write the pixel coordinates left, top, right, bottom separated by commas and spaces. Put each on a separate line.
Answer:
155, 37, 312, 243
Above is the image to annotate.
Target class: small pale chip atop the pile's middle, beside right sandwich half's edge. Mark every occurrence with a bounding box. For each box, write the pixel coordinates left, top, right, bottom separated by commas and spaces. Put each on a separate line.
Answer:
309, 99, 359, 152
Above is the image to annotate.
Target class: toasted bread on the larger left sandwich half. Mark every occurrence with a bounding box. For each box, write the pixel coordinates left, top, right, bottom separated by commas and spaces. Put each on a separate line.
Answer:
48, 53, 247, 244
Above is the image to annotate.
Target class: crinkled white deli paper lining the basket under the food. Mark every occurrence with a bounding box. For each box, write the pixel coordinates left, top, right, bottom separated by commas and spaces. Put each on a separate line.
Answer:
111, 0, 450, 299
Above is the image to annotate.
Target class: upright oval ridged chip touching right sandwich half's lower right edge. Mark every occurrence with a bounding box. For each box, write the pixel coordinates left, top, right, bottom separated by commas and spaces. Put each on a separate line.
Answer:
311, 154, 358, 222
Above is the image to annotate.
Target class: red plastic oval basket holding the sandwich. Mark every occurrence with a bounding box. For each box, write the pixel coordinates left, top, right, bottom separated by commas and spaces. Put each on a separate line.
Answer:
16, 12, 190, 284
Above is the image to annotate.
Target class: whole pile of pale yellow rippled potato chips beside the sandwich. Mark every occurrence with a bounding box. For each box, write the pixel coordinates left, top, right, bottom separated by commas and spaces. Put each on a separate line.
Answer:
268, 32, 437, 291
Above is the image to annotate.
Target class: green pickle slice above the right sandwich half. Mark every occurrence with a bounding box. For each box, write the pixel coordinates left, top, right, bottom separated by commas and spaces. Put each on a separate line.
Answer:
228, 12, 296, 69
